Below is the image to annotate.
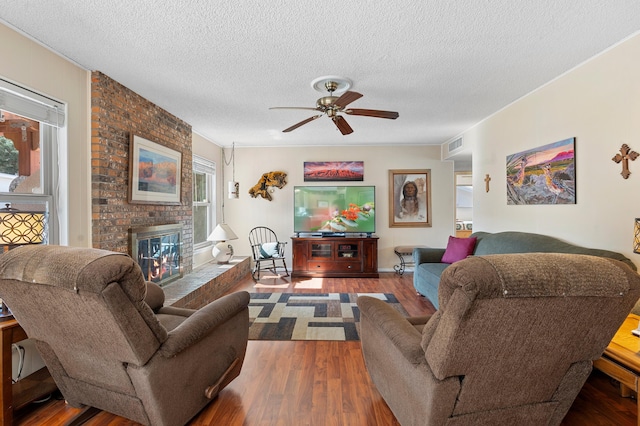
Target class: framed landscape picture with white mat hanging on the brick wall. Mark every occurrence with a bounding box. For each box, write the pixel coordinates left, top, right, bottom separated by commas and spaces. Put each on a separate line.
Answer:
129, 135, 182, 205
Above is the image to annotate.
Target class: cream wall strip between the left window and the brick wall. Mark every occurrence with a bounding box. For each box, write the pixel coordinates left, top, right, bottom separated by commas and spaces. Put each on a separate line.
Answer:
0, 25, 91, 247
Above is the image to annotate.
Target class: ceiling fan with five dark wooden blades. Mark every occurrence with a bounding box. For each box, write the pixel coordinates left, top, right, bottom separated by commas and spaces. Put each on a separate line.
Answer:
269, 77, 399, 135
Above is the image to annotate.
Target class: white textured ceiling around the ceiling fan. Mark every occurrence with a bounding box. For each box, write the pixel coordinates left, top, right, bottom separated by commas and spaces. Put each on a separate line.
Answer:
0, 0, 640, 151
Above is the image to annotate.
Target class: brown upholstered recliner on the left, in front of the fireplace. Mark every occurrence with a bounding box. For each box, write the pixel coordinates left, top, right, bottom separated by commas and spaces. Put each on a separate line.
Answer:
0, 246, 249, 426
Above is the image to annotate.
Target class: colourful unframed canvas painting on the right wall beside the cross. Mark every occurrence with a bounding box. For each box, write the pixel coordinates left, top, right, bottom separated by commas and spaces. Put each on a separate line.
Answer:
507, 138, 576, 204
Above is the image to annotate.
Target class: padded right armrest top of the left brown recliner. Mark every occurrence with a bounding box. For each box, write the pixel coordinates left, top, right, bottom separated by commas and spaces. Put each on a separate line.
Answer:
159, 291, 249, 358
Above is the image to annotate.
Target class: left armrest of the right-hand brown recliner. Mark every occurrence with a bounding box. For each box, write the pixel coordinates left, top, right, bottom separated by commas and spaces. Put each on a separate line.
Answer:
357, 296, 425, 364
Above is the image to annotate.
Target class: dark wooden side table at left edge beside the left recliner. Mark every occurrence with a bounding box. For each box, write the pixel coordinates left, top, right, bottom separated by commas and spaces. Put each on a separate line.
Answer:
0, 319, 56, 425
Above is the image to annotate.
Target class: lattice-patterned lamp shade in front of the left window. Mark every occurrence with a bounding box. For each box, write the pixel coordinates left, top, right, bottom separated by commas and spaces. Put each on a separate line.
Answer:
0, 204, 45, 245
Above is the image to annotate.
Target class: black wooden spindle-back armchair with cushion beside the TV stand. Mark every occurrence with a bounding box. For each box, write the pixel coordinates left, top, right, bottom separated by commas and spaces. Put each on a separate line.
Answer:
249, 226, 289, 280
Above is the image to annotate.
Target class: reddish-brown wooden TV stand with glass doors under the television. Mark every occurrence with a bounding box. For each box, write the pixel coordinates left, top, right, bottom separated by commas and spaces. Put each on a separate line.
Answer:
291, 236, 378, 278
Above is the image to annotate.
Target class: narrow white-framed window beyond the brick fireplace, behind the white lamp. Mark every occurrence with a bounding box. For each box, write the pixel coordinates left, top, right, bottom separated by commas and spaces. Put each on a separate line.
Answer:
193, 156, 216, 252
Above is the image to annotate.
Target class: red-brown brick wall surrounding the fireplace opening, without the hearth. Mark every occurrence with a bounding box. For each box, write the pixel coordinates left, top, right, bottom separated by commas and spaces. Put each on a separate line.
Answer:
91, 71, 193, 274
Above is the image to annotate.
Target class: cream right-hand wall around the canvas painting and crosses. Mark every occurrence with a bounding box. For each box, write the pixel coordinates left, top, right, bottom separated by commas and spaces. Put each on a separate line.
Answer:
463, 32, 640, 265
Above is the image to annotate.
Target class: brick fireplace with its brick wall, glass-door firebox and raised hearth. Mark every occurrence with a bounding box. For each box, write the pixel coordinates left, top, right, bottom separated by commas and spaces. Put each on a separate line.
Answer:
91, 71, 251, 309
